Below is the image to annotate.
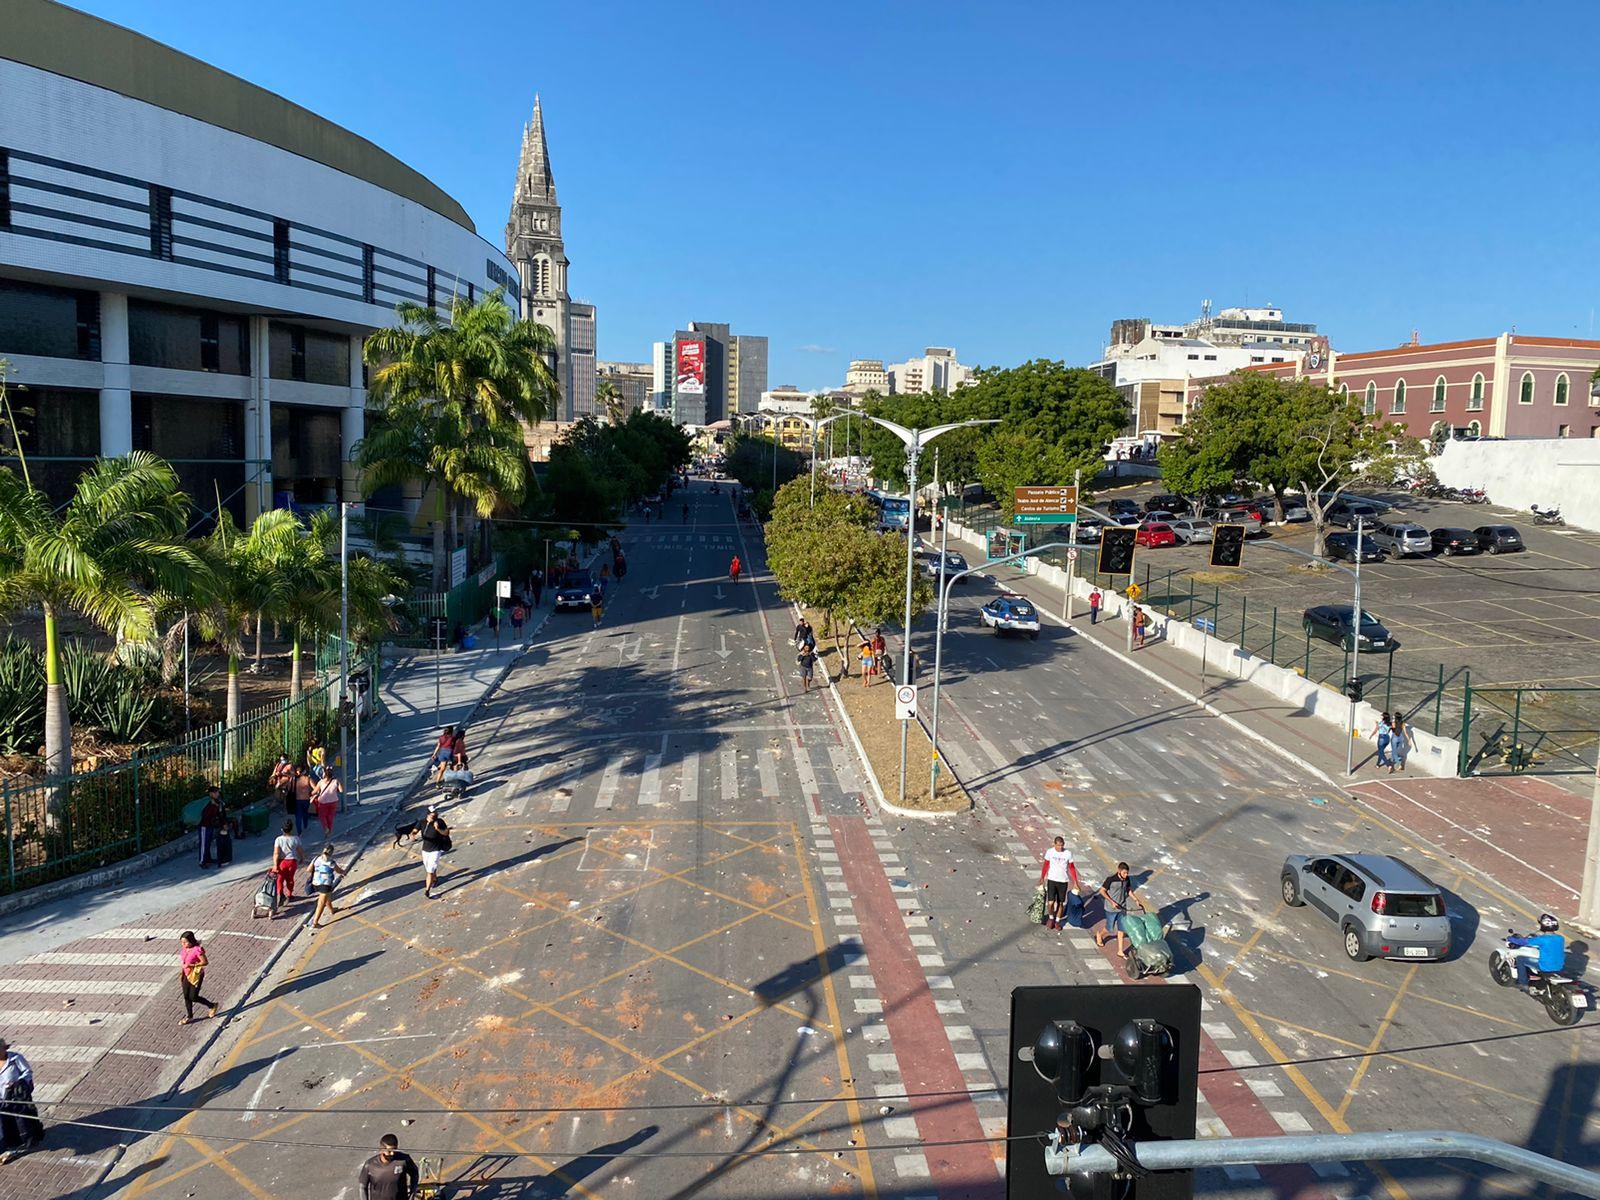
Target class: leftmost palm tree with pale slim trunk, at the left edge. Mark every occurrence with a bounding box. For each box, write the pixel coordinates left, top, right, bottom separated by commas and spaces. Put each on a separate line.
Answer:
0, 450, 203, 778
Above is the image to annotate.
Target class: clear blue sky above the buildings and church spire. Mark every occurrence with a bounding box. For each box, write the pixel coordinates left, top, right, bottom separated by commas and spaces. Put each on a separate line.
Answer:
68, 0, 1600, 387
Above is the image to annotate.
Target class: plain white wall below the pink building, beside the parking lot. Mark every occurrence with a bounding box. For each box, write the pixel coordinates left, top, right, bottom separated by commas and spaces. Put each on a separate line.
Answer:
1434, 438, 1600, 530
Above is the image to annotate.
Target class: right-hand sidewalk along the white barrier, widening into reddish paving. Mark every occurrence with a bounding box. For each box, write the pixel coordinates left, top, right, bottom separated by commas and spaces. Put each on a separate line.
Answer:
985, 563, 1589, 917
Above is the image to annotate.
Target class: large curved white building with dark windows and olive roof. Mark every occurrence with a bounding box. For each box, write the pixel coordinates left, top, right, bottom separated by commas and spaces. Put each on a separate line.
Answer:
0, 0, 515, 520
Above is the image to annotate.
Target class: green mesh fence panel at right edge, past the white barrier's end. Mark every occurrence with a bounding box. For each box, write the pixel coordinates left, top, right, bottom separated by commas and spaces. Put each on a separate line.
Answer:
1459, 685, 1600, 776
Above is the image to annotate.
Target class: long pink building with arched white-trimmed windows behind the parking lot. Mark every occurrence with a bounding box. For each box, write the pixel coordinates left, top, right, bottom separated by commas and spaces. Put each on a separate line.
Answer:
1187, 333, 1600, 438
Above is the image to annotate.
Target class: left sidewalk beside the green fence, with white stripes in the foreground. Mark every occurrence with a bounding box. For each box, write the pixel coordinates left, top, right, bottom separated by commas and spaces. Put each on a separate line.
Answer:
0, 610, 531, 1200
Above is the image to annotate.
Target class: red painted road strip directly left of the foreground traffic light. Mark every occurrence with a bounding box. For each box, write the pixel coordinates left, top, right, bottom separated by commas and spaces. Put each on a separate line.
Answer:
829, 816, 1005, 1200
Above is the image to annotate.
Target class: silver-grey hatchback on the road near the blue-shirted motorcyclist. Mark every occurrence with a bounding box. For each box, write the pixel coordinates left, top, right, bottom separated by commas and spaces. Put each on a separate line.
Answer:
1278, 854, 1450, 963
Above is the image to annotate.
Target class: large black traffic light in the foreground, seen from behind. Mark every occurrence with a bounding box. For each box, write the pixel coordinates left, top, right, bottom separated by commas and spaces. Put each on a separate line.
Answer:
1006, 984, 1200, 1200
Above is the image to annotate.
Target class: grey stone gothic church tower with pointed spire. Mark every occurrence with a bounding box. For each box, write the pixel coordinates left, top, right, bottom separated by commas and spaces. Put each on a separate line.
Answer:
506, 96, 573, 421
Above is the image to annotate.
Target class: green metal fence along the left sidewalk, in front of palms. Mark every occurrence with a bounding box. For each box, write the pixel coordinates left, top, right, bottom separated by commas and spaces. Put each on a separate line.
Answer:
0, 650, 379, 893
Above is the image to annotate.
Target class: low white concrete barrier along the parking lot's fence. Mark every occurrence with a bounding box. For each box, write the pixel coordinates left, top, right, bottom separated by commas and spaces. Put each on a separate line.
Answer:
950, 522, 1459, 779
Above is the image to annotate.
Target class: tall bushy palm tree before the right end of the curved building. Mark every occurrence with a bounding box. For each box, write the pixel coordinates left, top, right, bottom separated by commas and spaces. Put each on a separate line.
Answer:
360, 291, 558, 590
